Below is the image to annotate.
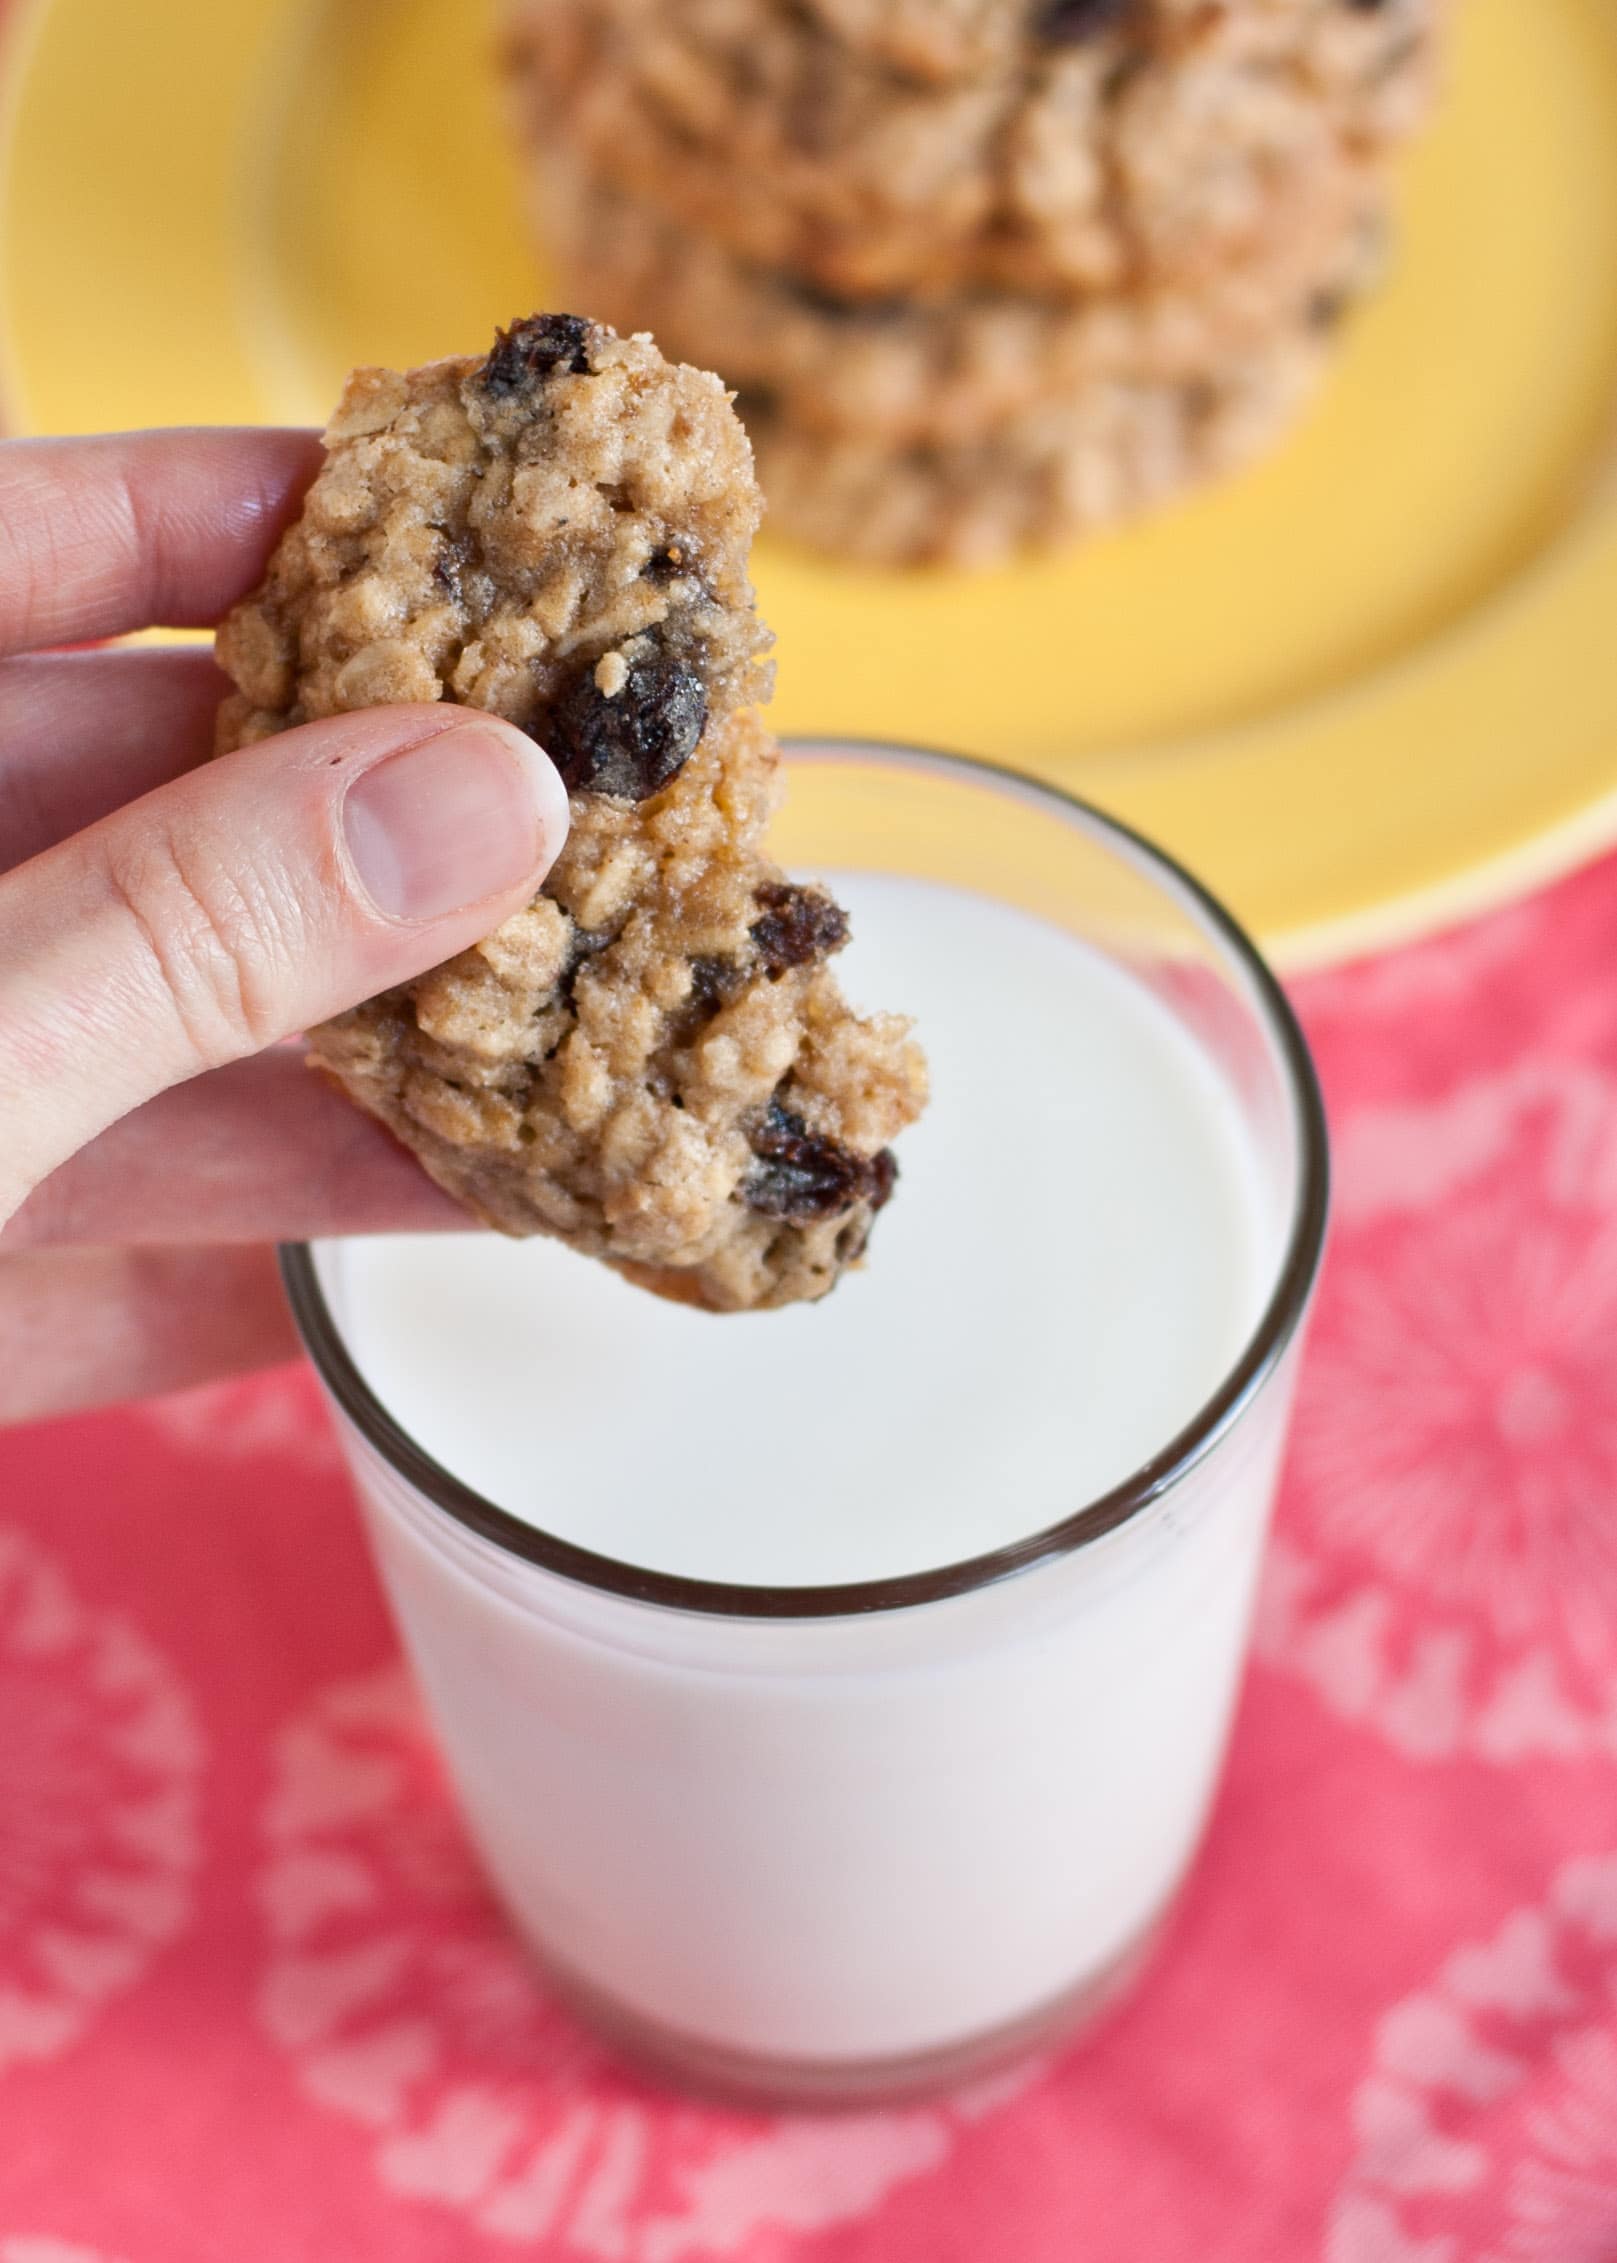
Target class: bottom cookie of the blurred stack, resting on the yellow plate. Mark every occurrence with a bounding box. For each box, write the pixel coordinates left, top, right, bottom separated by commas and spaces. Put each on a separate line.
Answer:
740, 328, 1328, 566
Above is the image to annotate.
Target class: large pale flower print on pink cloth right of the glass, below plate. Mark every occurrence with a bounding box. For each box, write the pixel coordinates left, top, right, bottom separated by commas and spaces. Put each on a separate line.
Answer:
1257, 1061, 1617, 1765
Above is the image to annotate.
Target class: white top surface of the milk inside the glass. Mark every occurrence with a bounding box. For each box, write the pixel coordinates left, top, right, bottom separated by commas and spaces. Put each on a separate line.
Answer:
341, 874, 1276, 1584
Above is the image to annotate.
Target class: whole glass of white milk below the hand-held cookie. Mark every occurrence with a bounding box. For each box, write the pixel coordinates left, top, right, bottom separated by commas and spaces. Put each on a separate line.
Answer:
285, 745, 1328, 2102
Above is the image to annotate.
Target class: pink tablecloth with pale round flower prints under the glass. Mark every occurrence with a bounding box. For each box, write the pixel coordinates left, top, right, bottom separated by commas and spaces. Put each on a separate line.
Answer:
0, 864, 1617, 2263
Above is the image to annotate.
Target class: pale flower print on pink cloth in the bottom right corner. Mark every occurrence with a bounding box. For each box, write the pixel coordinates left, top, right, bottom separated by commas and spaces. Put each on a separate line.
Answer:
1323, 1856, 1617, 2263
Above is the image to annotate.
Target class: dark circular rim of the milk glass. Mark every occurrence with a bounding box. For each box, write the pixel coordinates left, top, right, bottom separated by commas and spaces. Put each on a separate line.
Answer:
280, 735, 1330, 1620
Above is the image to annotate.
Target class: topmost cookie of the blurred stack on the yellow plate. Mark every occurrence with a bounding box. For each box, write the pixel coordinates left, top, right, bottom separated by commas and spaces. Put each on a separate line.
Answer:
507, 0, 1443, 296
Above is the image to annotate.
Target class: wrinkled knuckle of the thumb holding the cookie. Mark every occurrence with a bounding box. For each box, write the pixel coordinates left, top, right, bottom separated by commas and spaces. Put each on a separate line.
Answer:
109, 826, 296, 1068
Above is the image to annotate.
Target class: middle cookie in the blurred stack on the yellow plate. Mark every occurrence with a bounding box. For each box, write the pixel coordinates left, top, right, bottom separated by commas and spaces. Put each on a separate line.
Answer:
538, 147, 1386, 446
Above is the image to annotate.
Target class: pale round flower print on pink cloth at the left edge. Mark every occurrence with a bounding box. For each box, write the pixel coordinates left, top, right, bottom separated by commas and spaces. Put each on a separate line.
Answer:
0, 1528, 201, 2082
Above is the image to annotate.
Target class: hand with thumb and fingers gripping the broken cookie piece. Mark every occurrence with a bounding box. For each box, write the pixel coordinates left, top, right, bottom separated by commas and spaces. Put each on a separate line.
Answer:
0, 432, 568, 1421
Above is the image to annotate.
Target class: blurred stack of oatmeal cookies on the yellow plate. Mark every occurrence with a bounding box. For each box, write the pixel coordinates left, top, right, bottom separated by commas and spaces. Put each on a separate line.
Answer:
509, 0, 1443, 563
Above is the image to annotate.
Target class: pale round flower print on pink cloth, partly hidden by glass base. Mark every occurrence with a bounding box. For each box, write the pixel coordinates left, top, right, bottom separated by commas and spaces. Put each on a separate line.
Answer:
258, 1670, 1031, 2263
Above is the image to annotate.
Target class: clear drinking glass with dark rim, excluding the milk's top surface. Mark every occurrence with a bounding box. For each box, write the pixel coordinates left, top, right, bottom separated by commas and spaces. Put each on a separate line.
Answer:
283, 742, 1328, 2105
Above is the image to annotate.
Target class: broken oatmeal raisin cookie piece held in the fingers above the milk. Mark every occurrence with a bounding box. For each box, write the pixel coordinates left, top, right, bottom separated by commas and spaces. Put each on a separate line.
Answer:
219, 315, 925, 1310
